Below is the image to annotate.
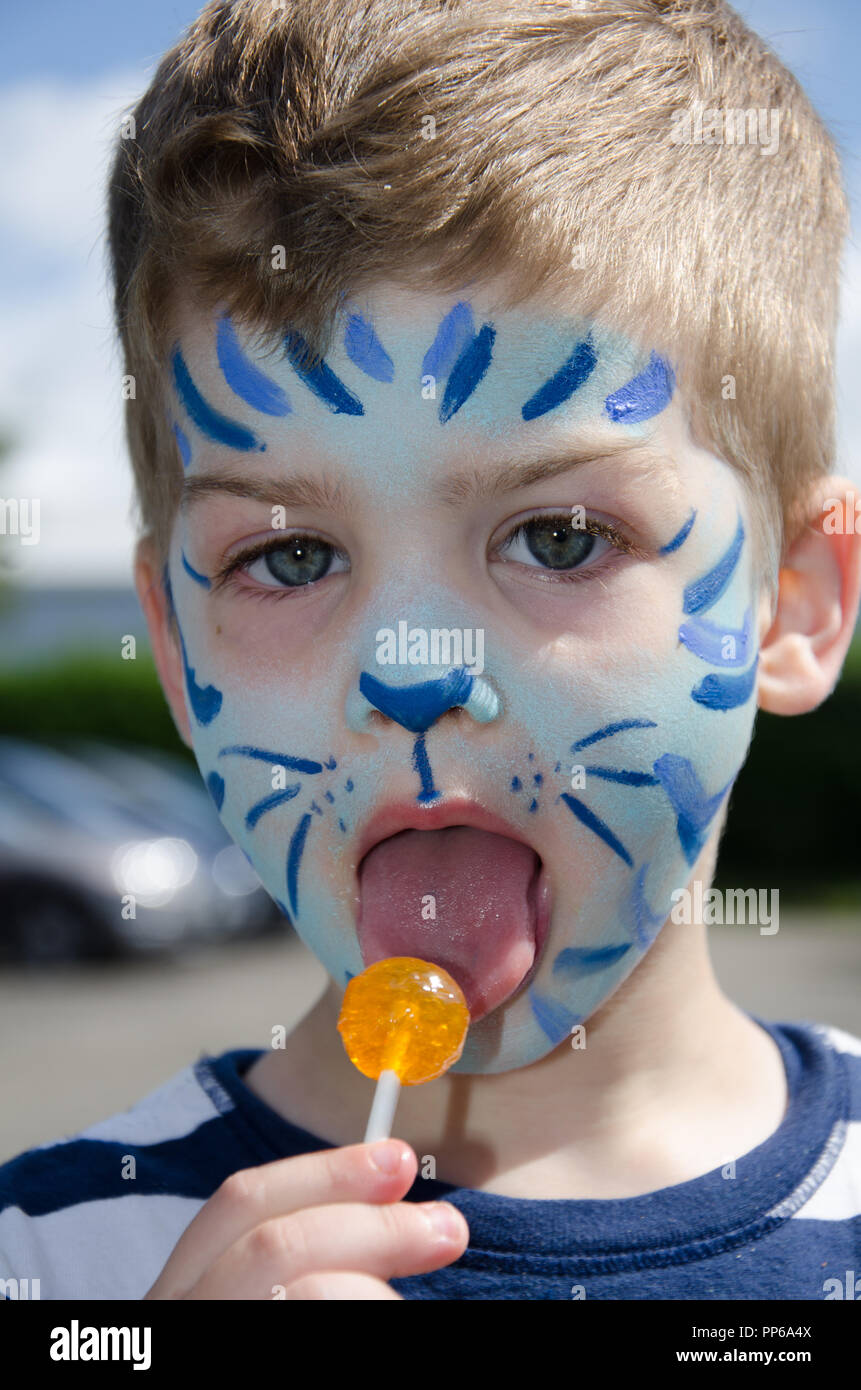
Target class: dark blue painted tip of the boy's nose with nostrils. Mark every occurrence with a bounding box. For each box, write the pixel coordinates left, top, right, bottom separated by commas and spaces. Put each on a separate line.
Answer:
348, 666, 499, 734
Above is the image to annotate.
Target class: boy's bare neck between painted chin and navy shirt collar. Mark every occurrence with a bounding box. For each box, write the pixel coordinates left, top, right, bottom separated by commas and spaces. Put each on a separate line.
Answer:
246, 922, 786, 1198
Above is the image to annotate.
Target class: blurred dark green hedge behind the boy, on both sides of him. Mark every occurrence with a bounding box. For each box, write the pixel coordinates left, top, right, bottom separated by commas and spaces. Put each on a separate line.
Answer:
0, 644, 861, 906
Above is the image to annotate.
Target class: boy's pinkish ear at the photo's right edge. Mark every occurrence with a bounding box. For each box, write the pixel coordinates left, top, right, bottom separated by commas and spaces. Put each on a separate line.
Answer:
757, 478, 861, 714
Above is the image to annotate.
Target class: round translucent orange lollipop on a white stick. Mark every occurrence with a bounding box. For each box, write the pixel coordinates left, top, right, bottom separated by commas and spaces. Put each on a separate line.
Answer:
338, 956, 469, 1144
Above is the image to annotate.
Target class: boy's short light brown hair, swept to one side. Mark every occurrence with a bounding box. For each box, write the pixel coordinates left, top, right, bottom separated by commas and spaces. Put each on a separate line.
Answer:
108, 0, 847, 580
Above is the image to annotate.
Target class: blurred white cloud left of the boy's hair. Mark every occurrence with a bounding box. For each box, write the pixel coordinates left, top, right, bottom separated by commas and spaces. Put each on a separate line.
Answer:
0, 74, 140, 584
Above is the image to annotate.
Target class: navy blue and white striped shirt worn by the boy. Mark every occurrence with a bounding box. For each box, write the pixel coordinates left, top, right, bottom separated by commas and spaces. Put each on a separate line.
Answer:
0, 1019, 861, 1300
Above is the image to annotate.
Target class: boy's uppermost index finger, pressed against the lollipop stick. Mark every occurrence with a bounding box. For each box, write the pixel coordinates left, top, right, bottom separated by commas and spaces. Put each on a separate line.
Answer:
146, 1138, 419, 1298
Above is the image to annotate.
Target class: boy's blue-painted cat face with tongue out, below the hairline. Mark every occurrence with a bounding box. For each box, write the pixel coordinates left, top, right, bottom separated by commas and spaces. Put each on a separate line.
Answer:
159, 276, 759, 1072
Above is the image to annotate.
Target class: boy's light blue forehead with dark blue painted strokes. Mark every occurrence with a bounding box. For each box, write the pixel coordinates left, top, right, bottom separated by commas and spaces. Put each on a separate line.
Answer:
170, 285, 675, 480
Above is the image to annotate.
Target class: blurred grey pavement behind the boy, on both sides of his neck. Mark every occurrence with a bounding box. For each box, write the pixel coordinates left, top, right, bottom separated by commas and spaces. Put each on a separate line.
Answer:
0, 912, 861, 1162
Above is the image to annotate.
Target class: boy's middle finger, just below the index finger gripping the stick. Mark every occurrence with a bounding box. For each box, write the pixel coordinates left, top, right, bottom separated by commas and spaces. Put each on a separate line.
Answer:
188, 1202, 469, 1300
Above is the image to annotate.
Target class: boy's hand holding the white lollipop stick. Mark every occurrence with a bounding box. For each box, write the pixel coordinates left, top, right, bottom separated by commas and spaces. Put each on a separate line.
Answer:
145, 1138, 469, 1301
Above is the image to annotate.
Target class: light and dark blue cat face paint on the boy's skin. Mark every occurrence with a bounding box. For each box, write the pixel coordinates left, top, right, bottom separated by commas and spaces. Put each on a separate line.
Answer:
164, 284, 754, 1073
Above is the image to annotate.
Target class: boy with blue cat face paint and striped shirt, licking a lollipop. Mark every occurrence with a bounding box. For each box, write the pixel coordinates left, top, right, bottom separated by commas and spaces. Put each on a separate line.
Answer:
0, 0, 861, 1300
